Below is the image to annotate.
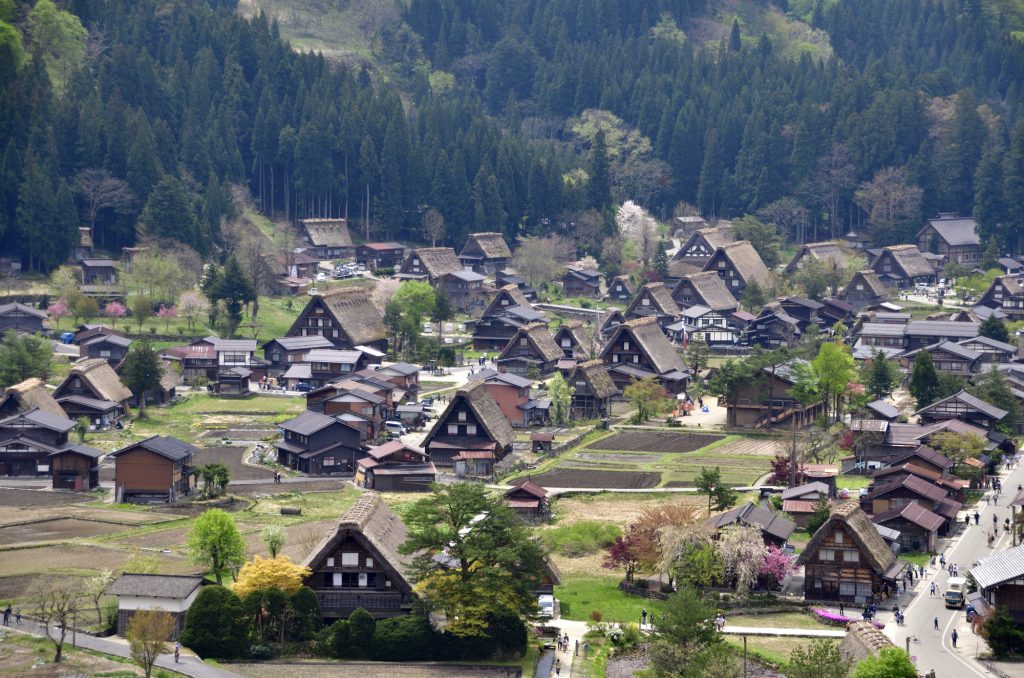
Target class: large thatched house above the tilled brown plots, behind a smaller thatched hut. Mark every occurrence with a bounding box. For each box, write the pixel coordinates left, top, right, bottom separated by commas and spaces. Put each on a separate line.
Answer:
600, 316, 690, 395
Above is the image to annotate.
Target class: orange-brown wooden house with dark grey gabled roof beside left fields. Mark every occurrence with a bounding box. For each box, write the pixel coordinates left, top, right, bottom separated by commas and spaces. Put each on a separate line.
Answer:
111, 435, 197, 504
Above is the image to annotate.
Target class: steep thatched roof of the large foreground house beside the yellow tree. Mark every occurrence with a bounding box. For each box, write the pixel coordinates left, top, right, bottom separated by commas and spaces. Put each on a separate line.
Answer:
302, 492, 413, 591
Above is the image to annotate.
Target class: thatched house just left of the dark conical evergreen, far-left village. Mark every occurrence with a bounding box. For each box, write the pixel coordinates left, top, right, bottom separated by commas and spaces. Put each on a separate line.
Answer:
53, 358, 132, 427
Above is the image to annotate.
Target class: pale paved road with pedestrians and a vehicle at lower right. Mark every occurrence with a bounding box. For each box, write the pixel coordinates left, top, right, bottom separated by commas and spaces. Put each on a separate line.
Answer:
882, 458, 1024, 678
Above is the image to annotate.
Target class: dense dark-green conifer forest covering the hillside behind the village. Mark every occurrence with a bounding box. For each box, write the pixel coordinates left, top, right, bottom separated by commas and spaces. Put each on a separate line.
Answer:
0, 0, 1024, 269
